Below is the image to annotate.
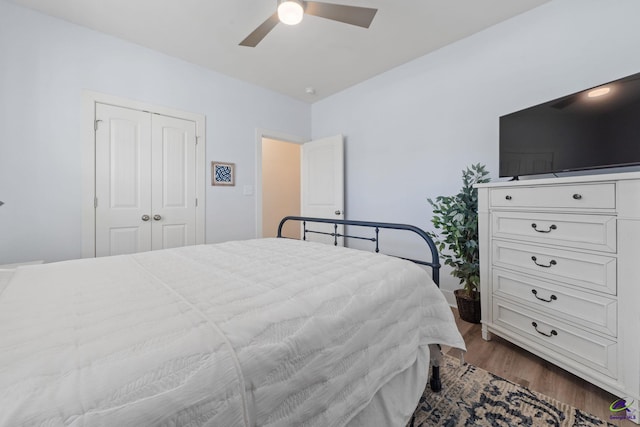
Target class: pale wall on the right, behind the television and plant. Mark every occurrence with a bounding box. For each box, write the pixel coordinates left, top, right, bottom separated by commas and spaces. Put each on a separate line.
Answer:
312, 0, 640, 301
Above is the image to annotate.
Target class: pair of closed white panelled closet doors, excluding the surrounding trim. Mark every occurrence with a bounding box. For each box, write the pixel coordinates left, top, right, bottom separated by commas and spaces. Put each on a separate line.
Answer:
95, 103, 197, 256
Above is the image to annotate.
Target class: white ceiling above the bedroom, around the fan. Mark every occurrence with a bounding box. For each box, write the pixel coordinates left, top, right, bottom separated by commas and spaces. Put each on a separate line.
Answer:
11, 0, 549, 103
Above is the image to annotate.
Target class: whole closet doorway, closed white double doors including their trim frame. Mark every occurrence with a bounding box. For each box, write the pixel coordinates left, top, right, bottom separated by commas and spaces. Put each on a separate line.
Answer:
82, 91, 206, 258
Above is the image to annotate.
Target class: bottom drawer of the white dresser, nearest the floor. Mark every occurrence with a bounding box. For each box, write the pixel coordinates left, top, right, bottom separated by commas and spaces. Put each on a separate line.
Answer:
493, 298, 617, 378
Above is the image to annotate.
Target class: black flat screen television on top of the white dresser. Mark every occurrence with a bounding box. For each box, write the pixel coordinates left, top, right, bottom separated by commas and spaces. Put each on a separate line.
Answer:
499, 73, 640, 178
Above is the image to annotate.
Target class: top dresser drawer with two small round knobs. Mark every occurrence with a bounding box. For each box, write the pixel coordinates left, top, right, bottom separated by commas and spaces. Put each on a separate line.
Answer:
490, 183, 616, 209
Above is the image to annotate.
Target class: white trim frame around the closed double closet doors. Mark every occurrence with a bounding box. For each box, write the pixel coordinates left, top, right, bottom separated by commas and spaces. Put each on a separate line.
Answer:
81, 90, 207, 258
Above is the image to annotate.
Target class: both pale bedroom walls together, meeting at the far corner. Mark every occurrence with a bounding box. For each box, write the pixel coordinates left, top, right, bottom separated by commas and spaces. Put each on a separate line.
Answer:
5, 0, 640, 290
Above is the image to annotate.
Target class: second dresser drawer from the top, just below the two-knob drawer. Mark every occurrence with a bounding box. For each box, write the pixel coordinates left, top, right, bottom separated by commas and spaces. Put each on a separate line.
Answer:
491, 211, 616, 252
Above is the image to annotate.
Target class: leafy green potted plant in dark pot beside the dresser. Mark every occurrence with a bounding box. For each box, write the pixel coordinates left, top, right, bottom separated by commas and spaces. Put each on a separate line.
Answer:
427, 163, 490, 323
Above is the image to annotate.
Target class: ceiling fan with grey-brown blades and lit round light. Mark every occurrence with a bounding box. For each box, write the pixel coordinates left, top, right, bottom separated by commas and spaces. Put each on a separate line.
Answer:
240, 0, 378, 47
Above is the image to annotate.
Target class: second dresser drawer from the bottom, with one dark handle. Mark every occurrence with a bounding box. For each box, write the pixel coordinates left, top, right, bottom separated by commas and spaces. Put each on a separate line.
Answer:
492, 268, 618, 337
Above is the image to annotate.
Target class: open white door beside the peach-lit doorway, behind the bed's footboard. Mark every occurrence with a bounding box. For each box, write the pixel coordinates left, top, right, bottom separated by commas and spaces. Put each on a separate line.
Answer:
301, 135, 344, 246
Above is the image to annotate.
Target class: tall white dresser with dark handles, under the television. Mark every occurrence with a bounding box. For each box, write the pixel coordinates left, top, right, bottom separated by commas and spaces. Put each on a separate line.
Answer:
477, 172, 640, 422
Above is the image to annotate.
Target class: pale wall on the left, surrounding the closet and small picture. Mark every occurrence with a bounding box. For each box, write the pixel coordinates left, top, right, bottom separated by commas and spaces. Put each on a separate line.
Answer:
0, 0, 311, 264
